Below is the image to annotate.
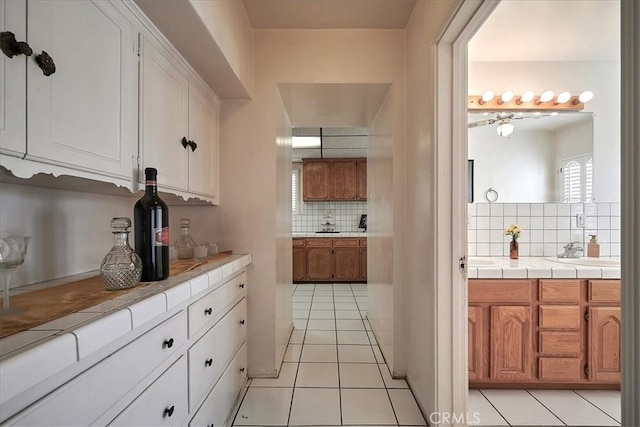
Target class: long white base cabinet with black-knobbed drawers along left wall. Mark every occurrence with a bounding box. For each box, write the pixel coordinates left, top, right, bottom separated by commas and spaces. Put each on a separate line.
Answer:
0, 257, 250, 426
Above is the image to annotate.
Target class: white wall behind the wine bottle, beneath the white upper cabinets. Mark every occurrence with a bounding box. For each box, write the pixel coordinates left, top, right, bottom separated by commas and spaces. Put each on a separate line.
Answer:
0, 183, 218, 287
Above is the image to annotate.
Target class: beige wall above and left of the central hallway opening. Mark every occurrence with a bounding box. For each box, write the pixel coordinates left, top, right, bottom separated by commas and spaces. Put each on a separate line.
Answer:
219, 30, 404, 376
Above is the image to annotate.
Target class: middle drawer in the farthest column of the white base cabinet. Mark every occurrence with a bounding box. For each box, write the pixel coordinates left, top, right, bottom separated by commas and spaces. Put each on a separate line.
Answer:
188, 299, 247, 411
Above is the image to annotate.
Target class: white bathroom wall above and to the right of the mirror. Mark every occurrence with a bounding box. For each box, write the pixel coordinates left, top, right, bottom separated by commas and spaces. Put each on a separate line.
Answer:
469, 61, 620, 202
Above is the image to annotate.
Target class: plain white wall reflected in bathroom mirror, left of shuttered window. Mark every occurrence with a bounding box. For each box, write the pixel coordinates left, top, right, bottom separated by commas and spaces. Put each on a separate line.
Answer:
468, 129, 558, 202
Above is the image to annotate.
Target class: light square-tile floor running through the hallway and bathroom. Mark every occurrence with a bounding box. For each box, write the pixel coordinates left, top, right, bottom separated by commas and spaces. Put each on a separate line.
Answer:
233, 283, 621, 426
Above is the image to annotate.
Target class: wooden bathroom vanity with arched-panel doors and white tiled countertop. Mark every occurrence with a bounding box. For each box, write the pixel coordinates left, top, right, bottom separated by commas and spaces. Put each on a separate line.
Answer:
468, 258, 621, 389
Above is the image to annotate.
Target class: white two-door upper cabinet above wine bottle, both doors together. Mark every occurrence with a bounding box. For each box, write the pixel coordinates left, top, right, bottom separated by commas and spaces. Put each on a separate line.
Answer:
140, 35, 218, 204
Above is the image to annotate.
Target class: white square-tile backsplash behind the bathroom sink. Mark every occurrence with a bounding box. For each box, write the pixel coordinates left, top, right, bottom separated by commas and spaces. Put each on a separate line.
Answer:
467, 203, 620, 257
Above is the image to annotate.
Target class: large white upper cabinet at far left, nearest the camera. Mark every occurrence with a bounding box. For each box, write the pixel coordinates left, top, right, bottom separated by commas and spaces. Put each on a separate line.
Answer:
0, 1, 138, 184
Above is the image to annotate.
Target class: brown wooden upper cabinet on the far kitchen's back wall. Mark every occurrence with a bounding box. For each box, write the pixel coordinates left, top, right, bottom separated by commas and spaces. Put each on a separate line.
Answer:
302, 159, 367, 202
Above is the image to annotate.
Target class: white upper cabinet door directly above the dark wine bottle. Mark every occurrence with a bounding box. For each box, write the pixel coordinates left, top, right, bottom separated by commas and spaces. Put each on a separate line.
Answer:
140, 36, 189, 191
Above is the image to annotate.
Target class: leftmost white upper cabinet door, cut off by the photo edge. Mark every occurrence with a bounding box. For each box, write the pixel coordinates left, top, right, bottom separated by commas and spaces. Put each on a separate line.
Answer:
0, 0, 27, 157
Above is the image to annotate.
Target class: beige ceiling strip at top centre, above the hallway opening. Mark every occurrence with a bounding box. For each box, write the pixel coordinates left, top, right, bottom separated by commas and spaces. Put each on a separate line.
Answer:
243, 0, 423, 29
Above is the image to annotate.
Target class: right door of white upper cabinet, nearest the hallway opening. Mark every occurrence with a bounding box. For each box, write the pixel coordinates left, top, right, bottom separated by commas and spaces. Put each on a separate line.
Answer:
189, 86, 218, 197
